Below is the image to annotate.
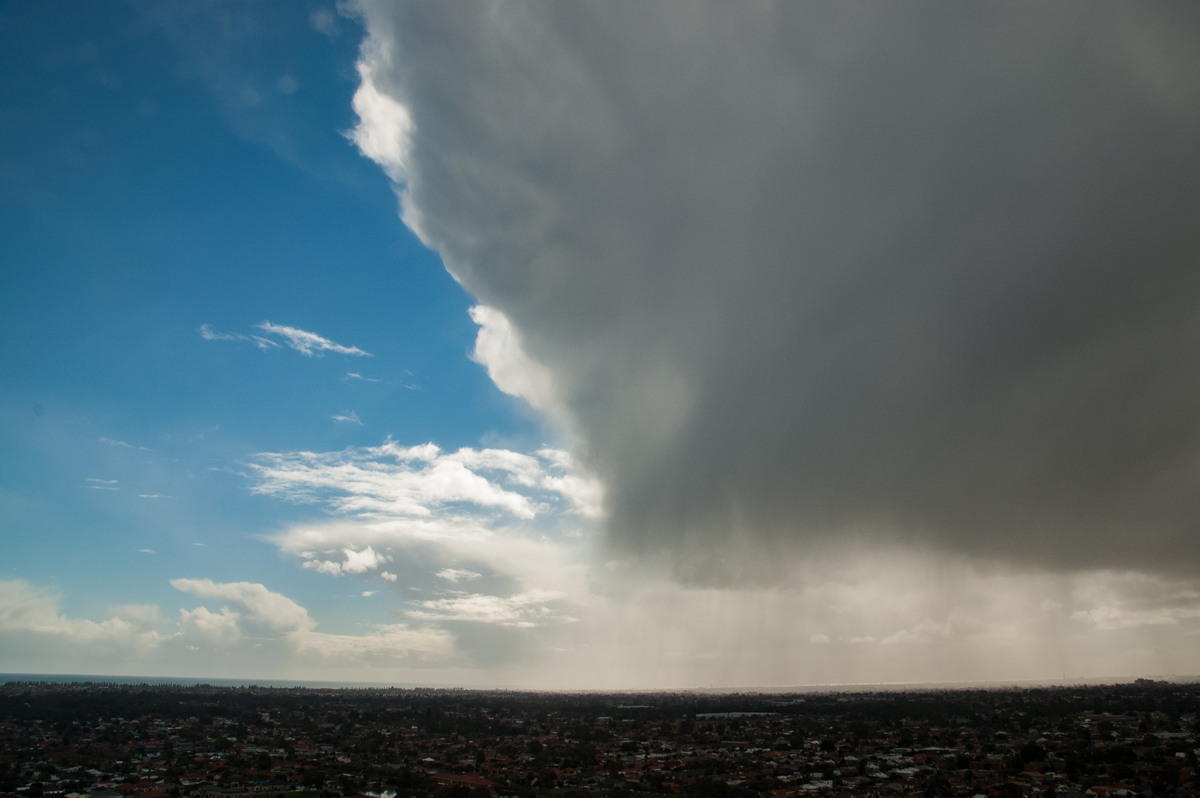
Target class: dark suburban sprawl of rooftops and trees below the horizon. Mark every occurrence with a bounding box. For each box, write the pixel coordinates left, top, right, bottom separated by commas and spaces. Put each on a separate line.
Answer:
0, 679, 1200, 798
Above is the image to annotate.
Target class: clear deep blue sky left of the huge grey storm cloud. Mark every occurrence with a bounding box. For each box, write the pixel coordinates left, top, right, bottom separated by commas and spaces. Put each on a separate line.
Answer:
0, 2, 561, 670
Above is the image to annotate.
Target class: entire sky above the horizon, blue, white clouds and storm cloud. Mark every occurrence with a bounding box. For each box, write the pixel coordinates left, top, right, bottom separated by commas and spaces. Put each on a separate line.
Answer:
0, 0, 1200, 689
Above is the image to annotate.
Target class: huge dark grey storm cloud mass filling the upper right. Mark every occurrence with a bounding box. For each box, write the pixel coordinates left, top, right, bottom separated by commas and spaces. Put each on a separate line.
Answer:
365, 2, 1200, 581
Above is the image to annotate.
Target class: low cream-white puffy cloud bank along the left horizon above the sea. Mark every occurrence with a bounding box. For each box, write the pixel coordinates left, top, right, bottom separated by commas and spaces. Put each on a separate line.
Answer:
0, 578, 460, 680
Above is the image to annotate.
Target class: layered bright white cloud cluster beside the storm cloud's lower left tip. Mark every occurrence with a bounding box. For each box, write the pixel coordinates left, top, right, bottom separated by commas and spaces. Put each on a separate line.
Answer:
252, 439, 598, 679
